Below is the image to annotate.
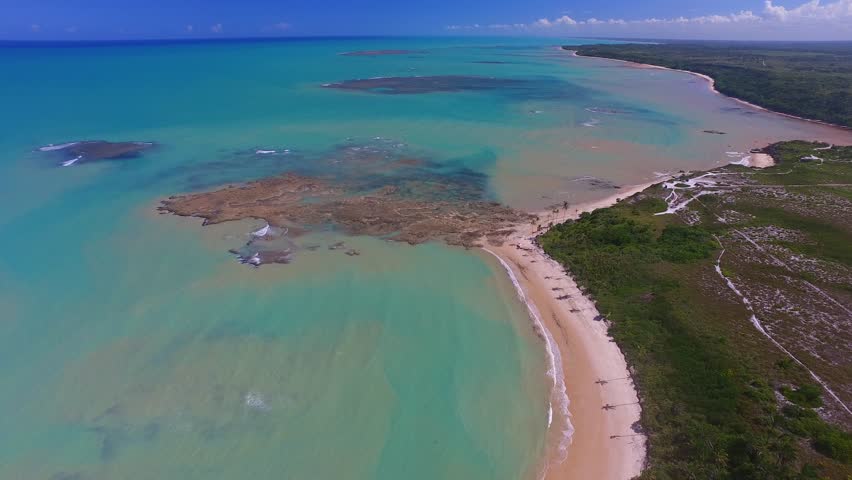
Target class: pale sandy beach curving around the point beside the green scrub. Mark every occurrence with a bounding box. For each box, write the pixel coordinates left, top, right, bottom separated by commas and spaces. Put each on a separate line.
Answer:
481, 181, 668, 480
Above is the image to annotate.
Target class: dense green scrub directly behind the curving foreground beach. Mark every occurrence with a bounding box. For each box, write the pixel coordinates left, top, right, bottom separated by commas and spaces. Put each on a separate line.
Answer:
538, 142, 852, 480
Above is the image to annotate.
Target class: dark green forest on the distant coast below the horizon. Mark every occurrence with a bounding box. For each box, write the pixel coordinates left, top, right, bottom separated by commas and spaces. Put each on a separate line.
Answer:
563, 42, 852, 126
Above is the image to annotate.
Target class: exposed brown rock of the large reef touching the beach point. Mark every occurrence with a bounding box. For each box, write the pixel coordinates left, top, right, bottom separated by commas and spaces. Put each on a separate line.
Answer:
159, 174, 535, 251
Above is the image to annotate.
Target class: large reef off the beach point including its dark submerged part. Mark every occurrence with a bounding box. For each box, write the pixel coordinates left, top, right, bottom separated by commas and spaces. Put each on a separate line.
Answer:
159, 137, 535, 266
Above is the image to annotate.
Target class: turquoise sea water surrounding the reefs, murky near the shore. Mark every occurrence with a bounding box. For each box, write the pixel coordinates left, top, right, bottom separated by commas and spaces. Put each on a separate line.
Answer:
0, 35, 844, 479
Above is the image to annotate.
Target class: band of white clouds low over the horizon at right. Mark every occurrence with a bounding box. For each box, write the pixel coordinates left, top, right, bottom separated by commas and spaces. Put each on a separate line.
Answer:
447, 0, 852, 39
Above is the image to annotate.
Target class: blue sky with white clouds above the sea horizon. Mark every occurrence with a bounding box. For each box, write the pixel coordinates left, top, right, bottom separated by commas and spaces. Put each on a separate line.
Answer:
0, 0, 852, 41
